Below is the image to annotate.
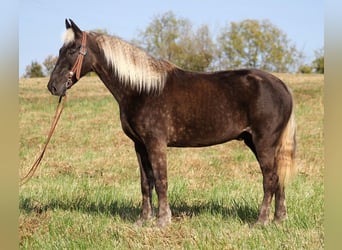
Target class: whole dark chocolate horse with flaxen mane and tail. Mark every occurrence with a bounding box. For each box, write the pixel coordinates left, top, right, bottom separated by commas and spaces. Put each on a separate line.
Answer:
47, 19, 296, 228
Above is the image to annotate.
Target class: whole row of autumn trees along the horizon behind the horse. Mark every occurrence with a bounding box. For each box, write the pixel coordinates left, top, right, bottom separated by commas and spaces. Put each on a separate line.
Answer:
24, 12, 324, 77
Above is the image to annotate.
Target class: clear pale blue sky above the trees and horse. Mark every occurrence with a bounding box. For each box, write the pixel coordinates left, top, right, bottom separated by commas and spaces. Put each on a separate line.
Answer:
18, 0, 324, 76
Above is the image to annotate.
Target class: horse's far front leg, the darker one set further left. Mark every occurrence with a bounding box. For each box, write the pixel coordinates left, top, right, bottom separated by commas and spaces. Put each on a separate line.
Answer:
135, 143, 154, 225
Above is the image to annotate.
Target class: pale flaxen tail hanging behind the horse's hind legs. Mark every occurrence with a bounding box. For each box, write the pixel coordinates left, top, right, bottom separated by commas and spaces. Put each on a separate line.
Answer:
276, 100, 297, 187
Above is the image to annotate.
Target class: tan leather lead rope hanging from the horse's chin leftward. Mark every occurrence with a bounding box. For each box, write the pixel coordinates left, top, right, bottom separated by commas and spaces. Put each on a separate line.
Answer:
20, 95, 67, 186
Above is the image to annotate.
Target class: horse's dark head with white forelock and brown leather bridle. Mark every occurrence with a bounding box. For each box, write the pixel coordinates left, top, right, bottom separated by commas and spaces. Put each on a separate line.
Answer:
47, 19, 92, 96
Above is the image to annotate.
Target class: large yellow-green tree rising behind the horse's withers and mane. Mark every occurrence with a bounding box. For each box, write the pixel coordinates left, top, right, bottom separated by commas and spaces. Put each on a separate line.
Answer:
134, 12, 214, 71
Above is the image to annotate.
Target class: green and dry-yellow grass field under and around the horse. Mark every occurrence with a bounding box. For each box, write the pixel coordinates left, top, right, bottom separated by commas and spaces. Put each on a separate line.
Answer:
19, 74, 324, 249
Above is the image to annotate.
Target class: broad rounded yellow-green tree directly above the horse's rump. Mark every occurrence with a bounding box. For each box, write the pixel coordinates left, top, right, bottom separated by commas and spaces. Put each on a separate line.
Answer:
218, 19, 301, 72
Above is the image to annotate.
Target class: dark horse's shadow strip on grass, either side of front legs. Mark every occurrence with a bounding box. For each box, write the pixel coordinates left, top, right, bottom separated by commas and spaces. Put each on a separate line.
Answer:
19, 197, 258, 224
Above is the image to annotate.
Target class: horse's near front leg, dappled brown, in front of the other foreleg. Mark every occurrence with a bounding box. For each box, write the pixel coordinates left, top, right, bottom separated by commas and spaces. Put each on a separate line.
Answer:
146, 138, 171, 227
